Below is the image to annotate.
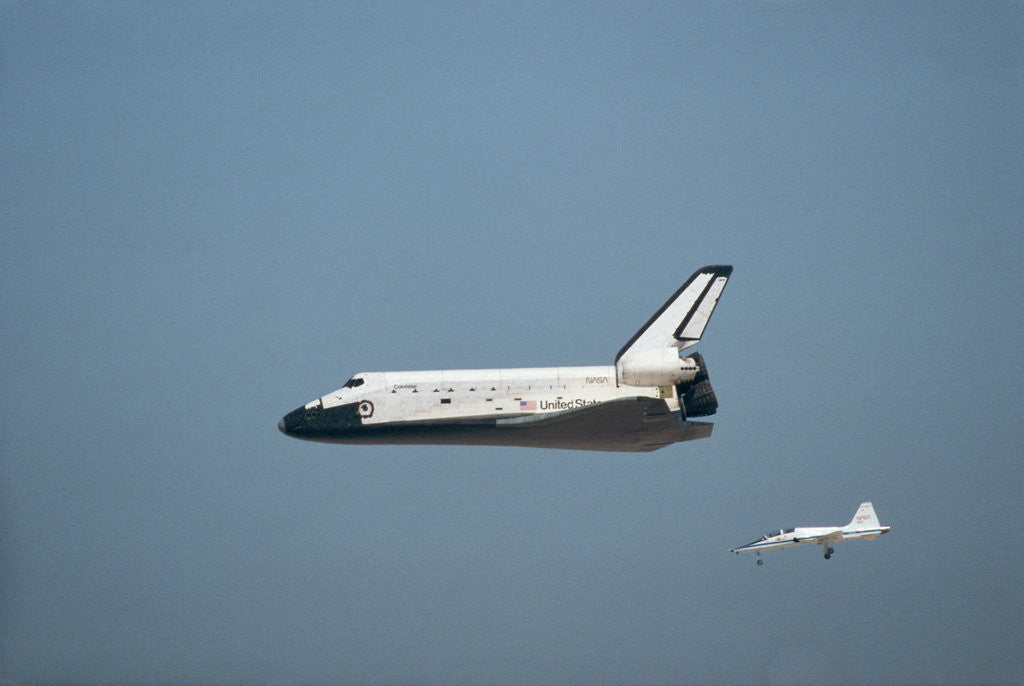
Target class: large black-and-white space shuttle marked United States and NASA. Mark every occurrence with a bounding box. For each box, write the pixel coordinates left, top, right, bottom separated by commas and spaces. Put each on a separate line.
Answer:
278, 265, 732, 452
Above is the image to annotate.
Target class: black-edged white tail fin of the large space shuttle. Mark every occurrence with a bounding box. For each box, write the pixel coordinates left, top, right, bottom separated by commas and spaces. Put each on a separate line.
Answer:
615, 265, 732, 363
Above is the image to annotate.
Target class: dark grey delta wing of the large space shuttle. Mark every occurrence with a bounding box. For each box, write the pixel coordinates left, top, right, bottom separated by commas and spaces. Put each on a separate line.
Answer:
495, 396, 714, 453
